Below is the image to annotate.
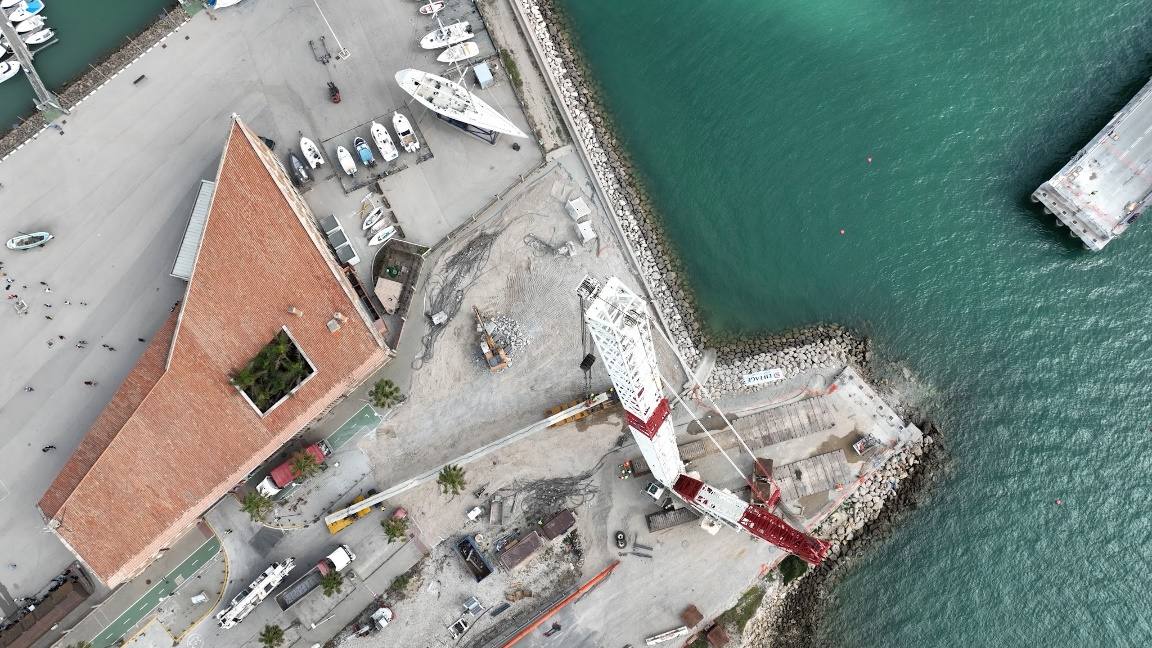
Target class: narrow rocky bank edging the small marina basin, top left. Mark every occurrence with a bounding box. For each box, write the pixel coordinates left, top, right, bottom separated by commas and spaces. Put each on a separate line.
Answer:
0, 6, 191, 161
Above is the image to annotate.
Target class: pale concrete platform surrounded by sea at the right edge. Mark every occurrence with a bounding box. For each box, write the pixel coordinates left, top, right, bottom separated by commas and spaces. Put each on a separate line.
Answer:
1032, 74, 1152, 251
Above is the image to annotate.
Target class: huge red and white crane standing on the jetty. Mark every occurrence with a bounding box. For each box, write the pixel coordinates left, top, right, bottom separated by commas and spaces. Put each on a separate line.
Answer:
579, 277, 828, 565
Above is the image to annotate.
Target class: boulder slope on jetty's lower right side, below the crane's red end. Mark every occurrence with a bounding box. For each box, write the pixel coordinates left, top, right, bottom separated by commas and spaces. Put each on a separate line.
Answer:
742, 423, 947, 648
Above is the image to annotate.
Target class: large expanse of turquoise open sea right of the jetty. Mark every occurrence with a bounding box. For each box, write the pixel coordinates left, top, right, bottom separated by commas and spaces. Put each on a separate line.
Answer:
562, 0, 1152, 648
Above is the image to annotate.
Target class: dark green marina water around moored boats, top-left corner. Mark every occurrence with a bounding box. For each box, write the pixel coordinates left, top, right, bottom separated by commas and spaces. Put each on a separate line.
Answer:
0, 0, 175, 131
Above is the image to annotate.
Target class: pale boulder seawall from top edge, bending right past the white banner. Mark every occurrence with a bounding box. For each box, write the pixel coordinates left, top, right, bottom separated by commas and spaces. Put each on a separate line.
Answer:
508, 0, 867, 394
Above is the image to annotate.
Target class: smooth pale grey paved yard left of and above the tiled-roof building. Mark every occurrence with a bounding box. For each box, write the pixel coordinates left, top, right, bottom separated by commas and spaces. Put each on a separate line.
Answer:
0, 0, 541, 596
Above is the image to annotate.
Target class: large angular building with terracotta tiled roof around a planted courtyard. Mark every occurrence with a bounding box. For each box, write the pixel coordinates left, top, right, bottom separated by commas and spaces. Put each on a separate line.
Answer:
39, 118, 389, 587
